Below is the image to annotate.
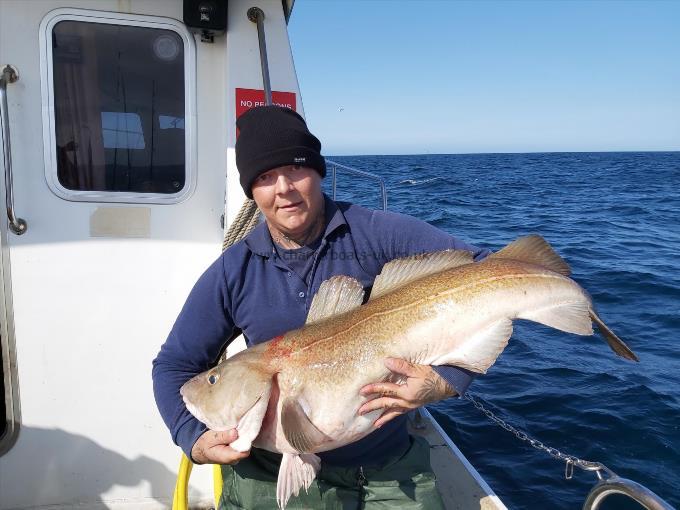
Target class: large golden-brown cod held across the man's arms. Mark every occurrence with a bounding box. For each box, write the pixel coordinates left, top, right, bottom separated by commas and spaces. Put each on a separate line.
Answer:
181, 236, 637, 508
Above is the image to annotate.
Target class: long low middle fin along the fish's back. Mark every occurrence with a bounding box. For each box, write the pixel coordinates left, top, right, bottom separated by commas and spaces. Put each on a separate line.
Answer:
371, 250, 473, 299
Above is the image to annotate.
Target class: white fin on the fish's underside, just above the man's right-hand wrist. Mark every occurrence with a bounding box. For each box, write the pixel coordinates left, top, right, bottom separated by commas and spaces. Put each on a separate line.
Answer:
430, 319, 512, 374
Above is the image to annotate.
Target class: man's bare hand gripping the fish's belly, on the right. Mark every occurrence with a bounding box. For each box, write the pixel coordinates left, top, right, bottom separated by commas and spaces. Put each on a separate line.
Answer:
358, 358, 456, 428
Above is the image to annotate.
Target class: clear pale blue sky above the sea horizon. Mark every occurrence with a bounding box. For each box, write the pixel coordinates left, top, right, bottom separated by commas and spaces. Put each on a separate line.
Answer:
289, 0, 680, 155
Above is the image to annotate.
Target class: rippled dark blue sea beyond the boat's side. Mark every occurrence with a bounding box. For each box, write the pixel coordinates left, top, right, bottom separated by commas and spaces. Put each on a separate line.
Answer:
325, 152, 680, 510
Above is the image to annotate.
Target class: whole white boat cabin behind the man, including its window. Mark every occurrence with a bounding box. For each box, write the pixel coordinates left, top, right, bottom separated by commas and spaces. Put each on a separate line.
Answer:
0, 0, 504, 509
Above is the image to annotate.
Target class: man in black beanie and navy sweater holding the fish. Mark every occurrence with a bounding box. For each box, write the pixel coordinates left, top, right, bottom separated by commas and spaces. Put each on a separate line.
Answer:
153, 106, 489, 509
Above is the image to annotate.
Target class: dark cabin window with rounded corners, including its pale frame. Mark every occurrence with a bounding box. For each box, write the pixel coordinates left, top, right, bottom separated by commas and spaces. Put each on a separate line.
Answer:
41, 11, 195, 203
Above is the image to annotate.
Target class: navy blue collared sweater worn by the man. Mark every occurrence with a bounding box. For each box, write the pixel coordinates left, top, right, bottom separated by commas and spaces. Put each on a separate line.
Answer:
153, 197, 490, 466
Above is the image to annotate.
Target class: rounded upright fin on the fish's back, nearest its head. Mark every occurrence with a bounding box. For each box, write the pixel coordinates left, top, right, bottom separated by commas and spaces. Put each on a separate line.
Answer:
306, 276, 364, 324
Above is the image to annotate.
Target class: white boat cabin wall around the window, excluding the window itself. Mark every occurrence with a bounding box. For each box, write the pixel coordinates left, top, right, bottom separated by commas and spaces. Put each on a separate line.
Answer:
0, 0, 301, 510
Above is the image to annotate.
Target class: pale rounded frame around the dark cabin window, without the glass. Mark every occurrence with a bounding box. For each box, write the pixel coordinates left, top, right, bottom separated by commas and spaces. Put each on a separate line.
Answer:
39, 8, 197, 204
